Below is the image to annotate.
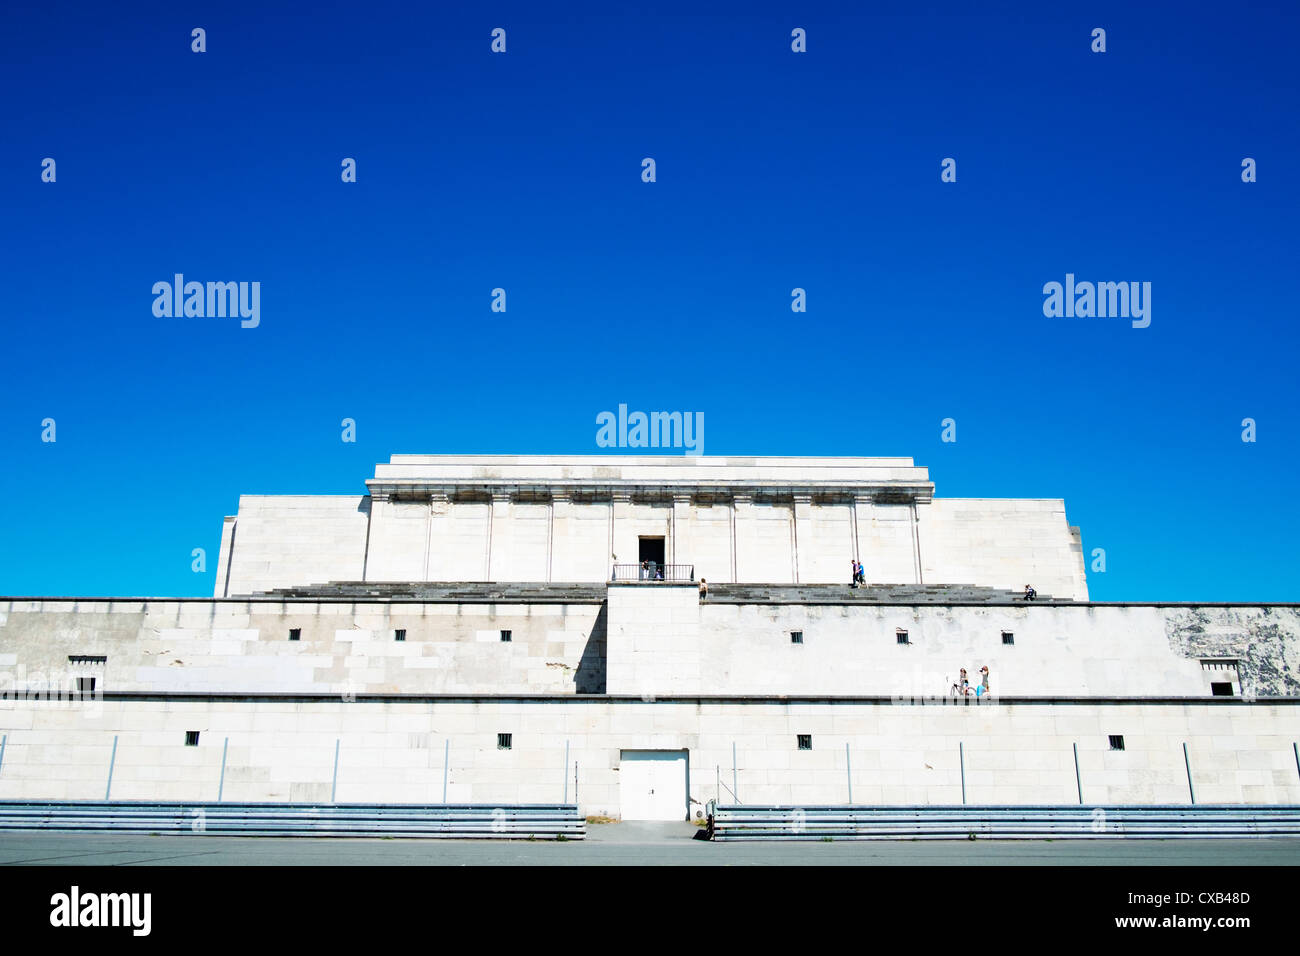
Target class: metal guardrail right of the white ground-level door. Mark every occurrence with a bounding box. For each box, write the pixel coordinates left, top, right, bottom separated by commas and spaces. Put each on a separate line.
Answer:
709, 801, 1300, 840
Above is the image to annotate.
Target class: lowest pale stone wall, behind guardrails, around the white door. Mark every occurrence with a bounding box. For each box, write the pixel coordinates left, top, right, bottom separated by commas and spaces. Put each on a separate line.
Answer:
0, 697, 1300, 817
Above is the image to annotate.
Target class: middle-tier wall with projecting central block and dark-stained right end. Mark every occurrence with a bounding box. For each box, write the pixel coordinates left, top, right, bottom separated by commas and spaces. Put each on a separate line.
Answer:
608, 584, 1300, 697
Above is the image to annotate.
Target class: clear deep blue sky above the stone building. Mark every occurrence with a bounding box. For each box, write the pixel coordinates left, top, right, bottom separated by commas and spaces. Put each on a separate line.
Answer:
0, 3, 1300, 601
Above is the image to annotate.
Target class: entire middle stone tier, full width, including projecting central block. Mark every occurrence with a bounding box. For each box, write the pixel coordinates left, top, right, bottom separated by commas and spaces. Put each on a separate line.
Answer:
0, 595, 1300, 697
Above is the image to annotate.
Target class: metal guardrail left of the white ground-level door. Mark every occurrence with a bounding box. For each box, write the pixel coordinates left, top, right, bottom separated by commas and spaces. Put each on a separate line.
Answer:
0, 800, 586, 840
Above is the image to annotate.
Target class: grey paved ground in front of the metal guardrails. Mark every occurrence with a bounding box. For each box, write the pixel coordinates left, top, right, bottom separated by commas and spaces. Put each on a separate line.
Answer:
0, 822, 1300, 866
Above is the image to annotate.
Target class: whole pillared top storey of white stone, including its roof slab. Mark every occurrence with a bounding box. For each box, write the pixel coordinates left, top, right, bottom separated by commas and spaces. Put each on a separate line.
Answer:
215, 455, 1088, 601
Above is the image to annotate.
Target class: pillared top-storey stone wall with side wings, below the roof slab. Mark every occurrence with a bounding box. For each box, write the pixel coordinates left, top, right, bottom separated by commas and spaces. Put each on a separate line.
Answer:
215, 493, 1088, 601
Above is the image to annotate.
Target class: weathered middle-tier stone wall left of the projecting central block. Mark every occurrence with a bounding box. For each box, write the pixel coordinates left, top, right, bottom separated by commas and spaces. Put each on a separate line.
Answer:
0, 600, 605, 696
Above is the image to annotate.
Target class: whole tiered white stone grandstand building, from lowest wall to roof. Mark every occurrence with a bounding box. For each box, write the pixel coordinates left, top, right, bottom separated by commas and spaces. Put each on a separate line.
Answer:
0, 455, 1300, 819
